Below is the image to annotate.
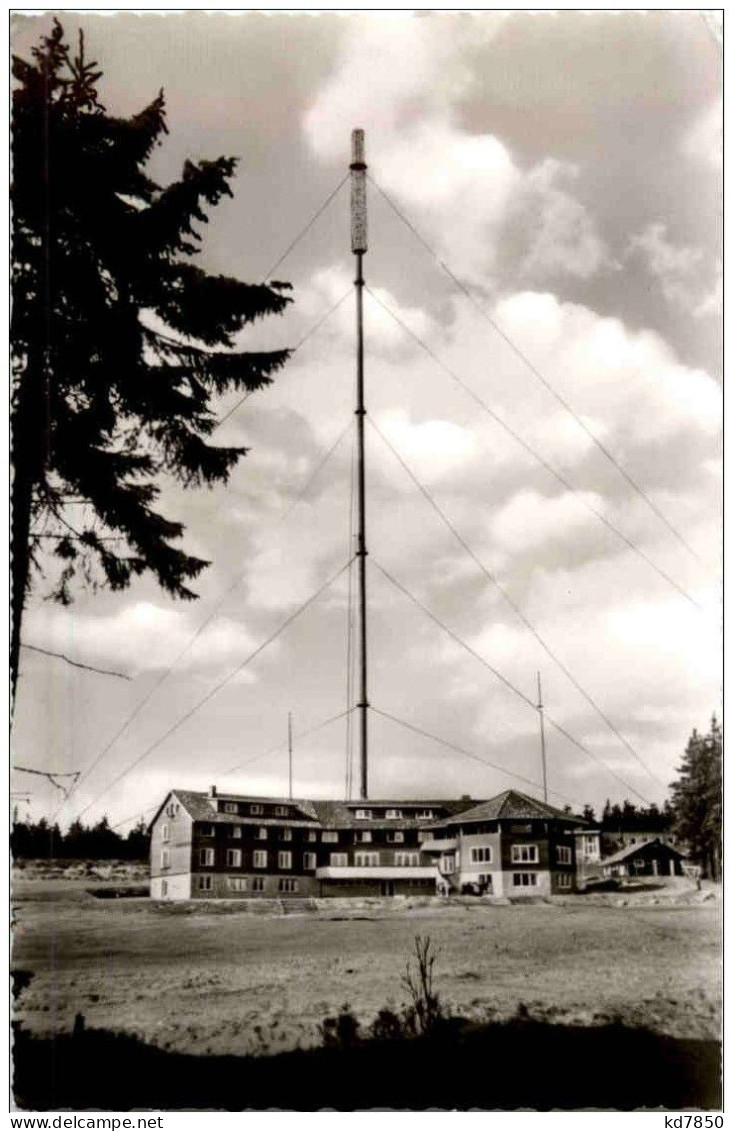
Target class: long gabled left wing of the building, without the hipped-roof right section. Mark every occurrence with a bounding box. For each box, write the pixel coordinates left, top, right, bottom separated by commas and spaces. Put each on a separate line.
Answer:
150, 787, 473, 899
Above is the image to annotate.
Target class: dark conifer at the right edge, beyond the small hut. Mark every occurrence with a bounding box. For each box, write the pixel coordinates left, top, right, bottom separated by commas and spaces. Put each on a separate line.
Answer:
671, 715, 723, 880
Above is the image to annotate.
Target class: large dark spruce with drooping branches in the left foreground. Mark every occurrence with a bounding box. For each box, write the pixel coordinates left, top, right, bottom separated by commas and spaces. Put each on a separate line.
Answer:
10, 21, 290, 689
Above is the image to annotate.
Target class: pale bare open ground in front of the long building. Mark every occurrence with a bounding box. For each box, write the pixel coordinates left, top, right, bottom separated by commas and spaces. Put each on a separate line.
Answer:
12, 872, 722, 1054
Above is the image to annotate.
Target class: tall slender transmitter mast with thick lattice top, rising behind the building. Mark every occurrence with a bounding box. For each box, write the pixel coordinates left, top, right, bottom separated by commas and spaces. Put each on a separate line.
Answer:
348, 130, 369, 801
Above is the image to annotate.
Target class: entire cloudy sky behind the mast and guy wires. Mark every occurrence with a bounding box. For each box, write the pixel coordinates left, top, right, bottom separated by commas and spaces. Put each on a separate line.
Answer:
12, 11, 722, 822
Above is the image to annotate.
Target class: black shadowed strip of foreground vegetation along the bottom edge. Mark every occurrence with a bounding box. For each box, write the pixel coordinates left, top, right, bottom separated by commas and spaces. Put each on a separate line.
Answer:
14, 1018, 722, 1112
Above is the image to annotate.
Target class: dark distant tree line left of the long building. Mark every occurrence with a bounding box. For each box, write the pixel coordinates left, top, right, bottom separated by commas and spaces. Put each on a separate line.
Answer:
10, 817, 150, 863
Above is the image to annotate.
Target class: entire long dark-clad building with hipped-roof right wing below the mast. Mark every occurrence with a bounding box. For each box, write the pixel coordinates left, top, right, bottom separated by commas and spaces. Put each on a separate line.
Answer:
150, 787, 584, 899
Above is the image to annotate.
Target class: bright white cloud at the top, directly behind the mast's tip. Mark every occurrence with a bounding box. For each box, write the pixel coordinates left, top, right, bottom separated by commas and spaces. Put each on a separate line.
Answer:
304, 16, 607, 285
